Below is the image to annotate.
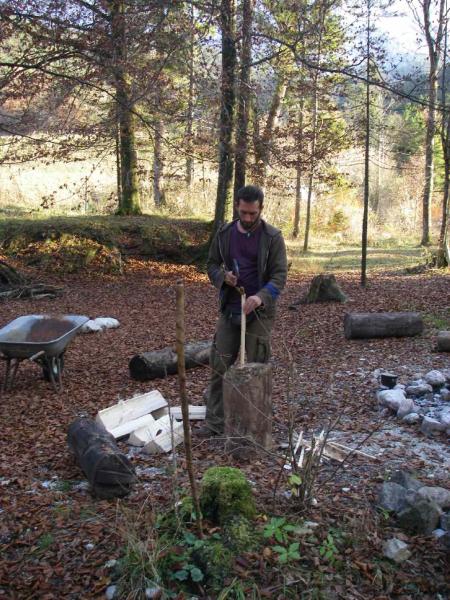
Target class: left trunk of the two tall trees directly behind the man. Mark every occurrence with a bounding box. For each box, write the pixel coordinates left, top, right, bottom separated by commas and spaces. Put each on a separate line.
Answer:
212, 0, 236, 236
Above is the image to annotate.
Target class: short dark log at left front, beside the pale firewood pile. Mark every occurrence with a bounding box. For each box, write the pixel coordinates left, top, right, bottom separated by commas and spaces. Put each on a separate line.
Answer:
67, 418, 136, 498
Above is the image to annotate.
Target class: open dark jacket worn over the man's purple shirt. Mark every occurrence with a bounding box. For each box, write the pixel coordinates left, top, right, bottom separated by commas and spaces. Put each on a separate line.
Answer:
207, 220, 287, 316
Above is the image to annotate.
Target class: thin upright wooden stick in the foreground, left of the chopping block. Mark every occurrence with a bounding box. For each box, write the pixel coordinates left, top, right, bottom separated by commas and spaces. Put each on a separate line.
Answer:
176, 279, 203, 538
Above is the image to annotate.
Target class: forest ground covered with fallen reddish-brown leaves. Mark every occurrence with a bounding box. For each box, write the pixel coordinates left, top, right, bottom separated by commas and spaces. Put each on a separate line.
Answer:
0, 245, 450, 600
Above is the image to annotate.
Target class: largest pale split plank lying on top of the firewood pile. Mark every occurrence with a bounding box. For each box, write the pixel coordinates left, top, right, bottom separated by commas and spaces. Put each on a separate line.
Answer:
95, 390, 167, 435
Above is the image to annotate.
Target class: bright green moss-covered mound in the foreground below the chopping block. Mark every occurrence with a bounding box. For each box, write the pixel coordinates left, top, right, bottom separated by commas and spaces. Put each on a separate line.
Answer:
200, 467, 256, 524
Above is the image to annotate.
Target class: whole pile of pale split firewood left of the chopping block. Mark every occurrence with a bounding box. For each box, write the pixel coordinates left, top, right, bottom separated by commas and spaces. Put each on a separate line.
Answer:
95, 390, 206, 454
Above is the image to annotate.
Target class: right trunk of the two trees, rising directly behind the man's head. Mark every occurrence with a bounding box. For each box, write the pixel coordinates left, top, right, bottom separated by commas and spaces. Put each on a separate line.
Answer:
233, 0, 254, 218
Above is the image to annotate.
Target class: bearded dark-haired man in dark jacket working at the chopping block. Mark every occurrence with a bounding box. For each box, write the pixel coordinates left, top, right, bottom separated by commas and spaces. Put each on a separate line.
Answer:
198, 185, 287, 437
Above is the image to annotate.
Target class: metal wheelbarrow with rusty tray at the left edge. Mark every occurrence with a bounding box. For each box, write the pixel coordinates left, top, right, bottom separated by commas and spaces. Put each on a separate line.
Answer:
0, 315, 89, 392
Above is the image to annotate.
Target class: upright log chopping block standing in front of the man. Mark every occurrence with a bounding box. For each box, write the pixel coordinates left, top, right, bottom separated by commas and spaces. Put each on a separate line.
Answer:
223, 363, 272, 459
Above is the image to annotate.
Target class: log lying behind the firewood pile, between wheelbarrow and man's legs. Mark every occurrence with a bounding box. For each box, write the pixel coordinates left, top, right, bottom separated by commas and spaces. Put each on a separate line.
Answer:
128, 340, 211, 381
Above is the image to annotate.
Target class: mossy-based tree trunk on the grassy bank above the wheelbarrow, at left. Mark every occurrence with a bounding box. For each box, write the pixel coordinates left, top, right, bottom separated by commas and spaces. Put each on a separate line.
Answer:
109, 0, 141, 215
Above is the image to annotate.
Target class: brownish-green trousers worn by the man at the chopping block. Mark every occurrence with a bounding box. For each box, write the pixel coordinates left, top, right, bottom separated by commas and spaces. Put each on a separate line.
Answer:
206, 310, 274, 433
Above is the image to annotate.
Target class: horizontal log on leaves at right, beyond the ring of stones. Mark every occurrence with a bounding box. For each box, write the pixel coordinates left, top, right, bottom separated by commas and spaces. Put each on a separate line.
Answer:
344, 312, 423, 340
